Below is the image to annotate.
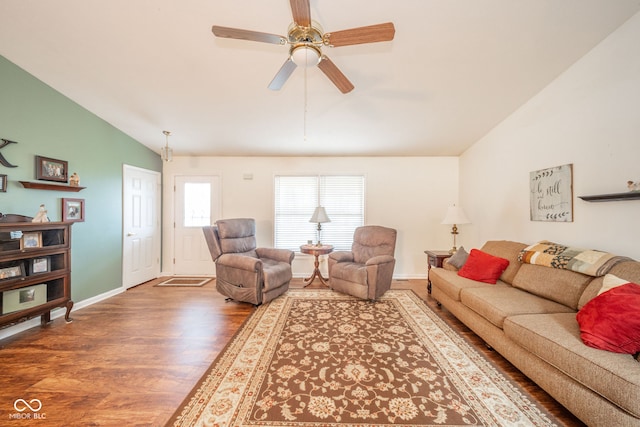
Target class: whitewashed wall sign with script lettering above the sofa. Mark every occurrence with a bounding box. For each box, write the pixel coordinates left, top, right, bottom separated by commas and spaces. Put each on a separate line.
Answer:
529, 164, 573, 222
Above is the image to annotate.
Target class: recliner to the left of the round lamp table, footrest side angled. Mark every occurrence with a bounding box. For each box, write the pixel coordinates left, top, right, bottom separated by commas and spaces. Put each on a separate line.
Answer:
202, 218, 295, 305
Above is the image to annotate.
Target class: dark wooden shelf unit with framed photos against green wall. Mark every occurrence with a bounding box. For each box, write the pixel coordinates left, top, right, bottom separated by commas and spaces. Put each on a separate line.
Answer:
0, 222, 73, 328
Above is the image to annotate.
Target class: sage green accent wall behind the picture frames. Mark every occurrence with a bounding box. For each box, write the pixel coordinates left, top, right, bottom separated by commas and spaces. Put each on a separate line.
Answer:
0, 56, 162, 302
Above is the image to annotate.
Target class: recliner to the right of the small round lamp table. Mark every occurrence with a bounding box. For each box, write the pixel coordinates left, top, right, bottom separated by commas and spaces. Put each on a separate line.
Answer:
329, 225, 397, 301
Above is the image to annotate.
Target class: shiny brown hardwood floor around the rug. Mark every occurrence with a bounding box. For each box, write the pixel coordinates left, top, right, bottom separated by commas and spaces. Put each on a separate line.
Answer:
0, 279, 583, 426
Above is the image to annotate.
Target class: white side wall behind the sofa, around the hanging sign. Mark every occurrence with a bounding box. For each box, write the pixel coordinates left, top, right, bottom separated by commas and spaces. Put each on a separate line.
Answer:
460, 14, 640, 259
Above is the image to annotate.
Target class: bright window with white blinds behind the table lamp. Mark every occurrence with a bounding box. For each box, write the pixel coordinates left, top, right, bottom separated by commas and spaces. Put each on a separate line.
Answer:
274, 175, 364, 251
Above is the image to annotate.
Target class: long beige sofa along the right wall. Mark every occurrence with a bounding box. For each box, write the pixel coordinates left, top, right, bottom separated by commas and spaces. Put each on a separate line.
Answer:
429, 241, 640, 427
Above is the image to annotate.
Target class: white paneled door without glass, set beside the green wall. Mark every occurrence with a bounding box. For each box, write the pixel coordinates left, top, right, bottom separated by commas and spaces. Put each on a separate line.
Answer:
122, 165, 161, 289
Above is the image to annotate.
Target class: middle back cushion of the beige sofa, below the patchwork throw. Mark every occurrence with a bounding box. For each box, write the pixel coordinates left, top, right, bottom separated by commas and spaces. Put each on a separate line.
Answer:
513, 264, 592, 310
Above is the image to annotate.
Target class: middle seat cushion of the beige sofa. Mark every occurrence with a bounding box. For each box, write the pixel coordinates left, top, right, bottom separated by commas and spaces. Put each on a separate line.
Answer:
460, 285, 575, 329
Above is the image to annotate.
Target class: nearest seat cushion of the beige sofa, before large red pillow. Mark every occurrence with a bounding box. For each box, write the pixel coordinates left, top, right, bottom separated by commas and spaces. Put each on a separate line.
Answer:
504, 313, 640, 417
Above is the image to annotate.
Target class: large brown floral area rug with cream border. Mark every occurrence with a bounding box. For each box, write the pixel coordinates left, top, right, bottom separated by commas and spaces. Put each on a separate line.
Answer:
167, 289, 556, 427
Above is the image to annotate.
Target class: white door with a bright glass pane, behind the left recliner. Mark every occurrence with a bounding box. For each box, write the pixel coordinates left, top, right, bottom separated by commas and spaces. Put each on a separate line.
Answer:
173, 175, 221, 276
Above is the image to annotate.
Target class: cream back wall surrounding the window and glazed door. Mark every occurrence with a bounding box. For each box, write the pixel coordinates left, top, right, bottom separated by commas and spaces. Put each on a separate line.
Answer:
163, 157, 458, 278
